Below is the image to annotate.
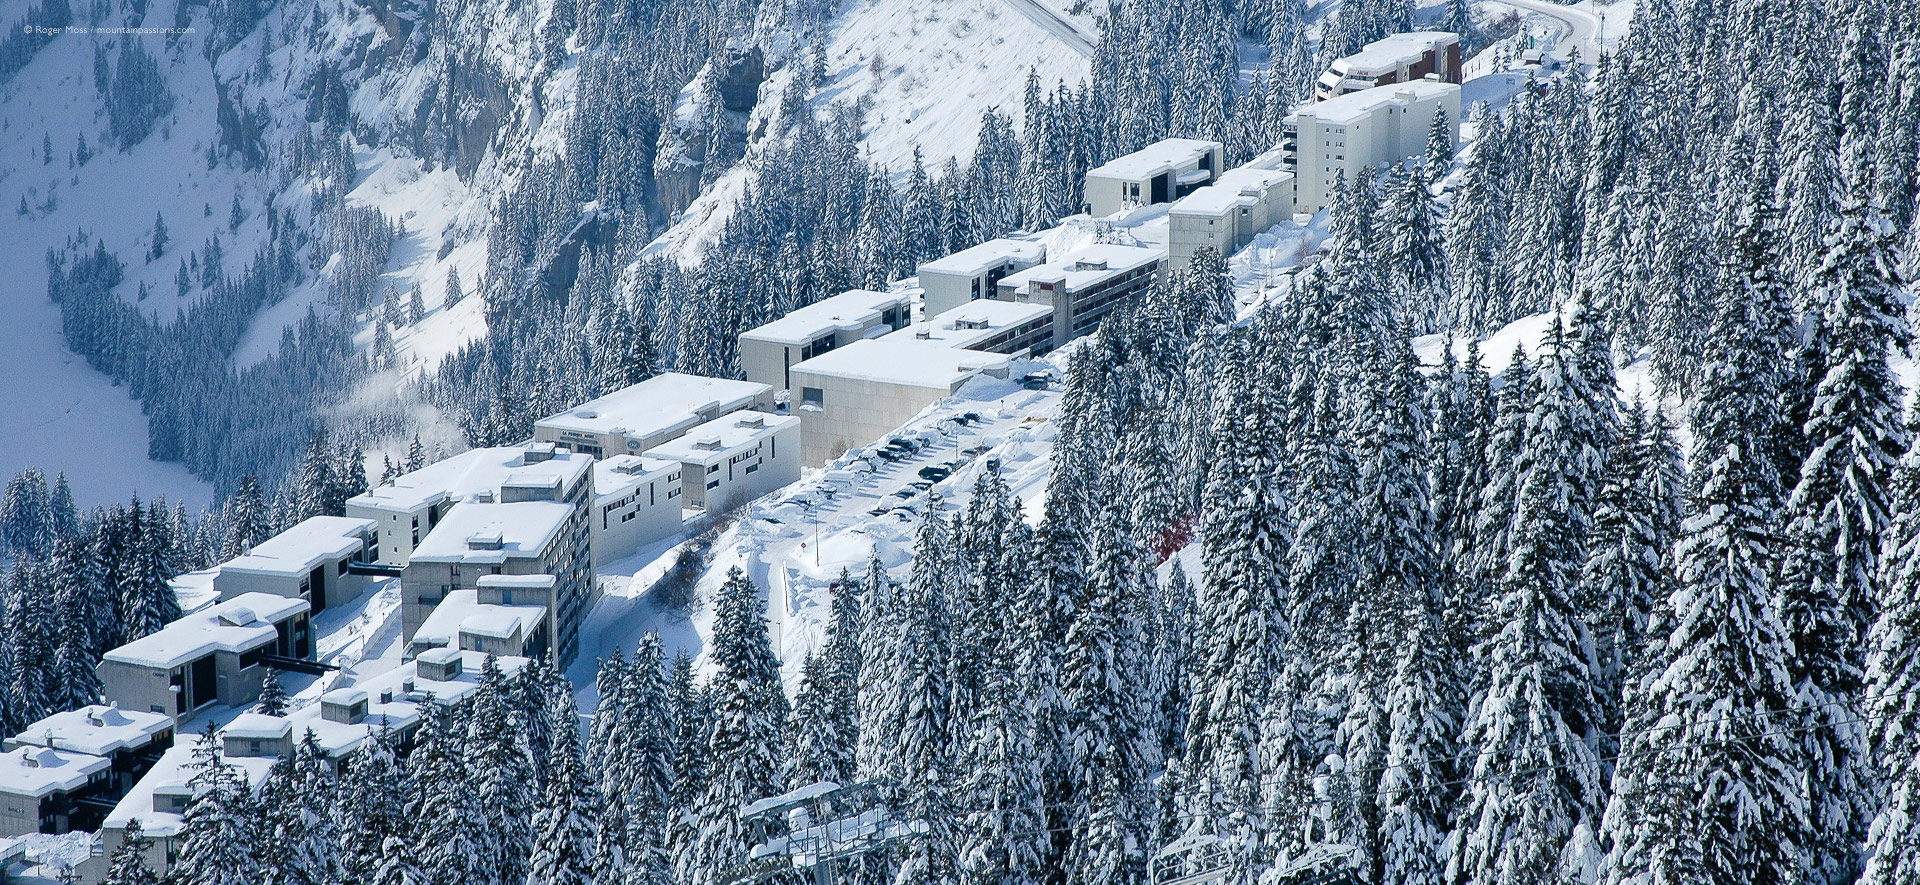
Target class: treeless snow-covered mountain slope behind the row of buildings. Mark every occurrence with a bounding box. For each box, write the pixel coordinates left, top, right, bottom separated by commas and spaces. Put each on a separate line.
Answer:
0, 0, 1096, 503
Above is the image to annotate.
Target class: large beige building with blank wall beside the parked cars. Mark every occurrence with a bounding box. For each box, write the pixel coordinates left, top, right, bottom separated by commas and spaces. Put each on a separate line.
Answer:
793, 338, 1010, 465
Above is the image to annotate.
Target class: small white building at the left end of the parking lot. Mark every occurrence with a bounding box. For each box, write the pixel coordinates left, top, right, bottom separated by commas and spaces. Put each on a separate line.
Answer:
647, 411, 803, 513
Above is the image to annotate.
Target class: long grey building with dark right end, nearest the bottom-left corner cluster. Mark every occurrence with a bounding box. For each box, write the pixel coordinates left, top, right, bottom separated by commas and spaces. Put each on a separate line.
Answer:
94, 593, 313, 722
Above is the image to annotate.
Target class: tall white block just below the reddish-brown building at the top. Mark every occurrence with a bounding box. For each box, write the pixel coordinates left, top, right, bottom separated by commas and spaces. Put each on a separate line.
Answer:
1281, 81, 1459, 213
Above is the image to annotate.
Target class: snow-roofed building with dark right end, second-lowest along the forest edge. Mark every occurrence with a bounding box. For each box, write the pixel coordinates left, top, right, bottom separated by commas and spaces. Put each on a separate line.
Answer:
213, 516, 380, 614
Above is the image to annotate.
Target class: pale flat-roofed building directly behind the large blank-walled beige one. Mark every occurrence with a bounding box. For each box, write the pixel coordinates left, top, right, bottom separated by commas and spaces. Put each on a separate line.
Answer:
737, 288, 912, 393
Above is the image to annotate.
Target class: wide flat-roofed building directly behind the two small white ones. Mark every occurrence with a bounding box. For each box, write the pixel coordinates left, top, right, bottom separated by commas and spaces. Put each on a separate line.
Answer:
534, 372, 774, 459
